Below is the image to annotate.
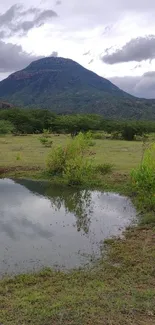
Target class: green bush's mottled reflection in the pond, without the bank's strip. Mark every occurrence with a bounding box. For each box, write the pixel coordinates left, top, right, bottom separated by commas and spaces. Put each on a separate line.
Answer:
46, 187, 93, 234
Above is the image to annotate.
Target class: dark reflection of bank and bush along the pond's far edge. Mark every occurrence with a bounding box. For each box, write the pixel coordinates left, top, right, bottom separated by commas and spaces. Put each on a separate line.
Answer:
16, 180, 93, 234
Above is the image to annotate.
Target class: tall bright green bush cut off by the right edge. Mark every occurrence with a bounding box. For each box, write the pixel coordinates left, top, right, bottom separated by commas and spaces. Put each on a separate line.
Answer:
131, 144, 155, 210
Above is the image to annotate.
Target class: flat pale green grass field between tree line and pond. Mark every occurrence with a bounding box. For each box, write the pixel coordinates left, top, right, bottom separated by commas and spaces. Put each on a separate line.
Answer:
0, 135, 142, 173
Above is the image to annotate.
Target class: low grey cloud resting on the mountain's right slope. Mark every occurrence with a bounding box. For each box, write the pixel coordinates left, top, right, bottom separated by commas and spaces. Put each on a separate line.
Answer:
110, 71, 155, 98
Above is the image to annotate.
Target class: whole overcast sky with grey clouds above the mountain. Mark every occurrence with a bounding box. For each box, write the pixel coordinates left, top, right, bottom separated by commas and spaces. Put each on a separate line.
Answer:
0, 0, 155, 98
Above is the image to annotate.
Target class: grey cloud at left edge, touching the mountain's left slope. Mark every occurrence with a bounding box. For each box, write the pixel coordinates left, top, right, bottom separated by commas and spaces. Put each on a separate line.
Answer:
0, 40, 41, 73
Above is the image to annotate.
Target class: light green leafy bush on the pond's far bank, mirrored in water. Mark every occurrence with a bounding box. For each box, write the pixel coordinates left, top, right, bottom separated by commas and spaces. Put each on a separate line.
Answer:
47, 133, 92, 185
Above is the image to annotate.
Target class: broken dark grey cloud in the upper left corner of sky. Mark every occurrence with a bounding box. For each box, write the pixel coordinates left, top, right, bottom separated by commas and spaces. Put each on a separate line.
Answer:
0, 4, 58, 38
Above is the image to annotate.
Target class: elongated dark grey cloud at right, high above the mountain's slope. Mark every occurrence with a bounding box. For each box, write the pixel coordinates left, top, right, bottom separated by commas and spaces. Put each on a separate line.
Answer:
101, 35, 155, 64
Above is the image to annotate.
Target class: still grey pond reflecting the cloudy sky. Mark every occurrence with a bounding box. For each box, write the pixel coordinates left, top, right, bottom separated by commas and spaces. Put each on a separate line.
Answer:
0, 179, 136, 276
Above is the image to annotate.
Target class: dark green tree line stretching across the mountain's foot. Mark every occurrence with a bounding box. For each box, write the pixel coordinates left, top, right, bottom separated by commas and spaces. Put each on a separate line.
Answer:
0, 108, 155, 140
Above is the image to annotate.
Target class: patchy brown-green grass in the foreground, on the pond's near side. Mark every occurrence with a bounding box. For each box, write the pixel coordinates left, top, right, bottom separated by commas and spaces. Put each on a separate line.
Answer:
0, 228, 155, 325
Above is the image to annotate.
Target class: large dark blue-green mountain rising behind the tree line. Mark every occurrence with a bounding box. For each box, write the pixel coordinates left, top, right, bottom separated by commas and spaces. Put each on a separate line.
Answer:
0, 57, 155, 119
